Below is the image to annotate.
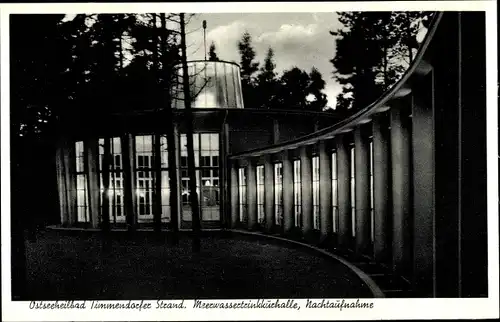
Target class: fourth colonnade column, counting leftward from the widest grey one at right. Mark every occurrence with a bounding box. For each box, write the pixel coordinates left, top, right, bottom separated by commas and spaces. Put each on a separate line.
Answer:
354, 126, 371, 255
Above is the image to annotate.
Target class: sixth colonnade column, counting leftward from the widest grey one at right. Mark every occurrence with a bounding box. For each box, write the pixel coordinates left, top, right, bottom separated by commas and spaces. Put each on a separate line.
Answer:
318, 141, 333, 241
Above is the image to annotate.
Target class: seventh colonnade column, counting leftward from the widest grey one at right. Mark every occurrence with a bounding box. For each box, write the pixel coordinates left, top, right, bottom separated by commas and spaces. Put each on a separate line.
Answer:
300, 146, 313, 236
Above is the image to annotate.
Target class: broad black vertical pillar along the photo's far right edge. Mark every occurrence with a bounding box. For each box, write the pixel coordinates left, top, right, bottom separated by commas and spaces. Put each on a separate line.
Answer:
458, 12, 491, 297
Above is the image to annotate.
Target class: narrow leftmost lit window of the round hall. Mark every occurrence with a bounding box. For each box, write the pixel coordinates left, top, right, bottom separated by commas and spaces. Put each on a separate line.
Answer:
75, 141, 90, 222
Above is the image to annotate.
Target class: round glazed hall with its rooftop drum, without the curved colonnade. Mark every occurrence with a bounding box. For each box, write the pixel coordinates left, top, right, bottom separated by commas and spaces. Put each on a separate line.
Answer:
53, 61, 340, 229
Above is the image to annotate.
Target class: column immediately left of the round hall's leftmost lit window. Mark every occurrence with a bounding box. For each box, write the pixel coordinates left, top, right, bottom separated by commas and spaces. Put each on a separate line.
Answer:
63, 140, 77, 226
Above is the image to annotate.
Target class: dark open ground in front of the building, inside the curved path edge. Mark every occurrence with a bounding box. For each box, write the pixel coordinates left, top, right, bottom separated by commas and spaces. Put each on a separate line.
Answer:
26, 231, 372, 300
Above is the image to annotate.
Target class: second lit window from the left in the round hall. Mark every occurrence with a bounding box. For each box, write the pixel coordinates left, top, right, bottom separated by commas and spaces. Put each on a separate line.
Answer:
99, 137, 125, 223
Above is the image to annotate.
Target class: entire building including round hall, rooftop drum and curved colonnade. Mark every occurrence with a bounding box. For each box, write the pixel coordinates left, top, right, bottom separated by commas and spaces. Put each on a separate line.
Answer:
52, 12, 488, 297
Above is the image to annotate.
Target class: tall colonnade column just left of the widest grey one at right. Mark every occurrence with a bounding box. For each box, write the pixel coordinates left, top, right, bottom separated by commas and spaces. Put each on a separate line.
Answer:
391, 101, 412, 276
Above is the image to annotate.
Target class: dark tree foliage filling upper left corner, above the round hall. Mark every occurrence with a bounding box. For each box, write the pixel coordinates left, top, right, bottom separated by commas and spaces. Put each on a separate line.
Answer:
11, 14, 179, 141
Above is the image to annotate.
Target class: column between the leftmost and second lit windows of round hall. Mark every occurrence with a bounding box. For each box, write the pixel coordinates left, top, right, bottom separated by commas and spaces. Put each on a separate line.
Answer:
84, 138, 100, 228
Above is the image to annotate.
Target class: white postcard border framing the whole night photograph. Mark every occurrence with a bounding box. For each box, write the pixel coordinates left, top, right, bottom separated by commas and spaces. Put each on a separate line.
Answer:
0, 0, 499, 321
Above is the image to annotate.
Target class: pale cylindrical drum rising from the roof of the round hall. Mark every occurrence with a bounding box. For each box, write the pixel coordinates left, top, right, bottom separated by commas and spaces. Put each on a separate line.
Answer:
172, 61, 243, 108
